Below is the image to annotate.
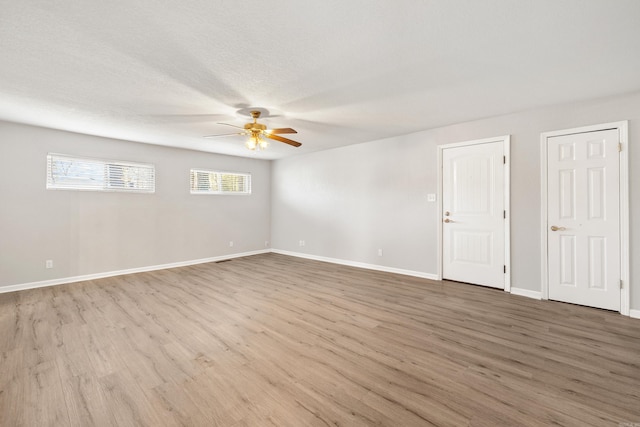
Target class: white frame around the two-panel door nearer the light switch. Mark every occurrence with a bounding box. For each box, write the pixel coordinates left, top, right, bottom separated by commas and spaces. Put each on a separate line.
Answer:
437, 135, 511, 292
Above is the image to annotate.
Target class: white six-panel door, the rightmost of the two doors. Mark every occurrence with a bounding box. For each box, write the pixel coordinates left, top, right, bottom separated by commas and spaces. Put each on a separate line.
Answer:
547, 129, 620, 311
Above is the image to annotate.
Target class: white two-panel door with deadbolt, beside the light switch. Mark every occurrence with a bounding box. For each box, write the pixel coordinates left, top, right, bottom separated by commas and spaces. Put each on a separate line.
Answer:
442, 141, 505, 289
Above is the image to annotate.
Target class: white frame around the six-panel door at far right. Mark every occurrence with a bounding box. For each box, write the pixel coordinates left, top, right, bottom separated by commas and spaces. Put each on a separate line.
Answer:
540, 120, 631, 316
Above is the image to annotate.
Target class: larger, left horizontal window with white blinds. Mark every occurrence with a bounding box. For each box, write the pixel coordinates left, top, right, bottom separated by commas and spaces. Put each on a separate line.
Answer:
47, 154, 156, 193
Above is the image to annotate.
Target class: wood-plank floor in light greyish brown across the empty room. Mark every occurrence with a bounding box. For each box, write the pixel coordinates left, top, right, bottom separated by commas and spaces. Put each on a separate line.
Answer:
0, 254, 640, 427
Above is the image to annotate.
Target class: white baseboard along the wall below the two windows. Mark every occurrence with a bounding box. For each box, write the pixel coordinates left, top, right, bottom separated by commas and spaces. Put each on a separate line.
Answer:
0, 249, 271, 294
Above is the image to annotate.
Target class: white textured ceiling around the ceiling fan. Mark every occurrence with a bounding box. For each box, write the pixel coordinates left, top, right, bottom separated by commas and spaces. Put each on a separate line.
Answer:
0, 0, 640, 159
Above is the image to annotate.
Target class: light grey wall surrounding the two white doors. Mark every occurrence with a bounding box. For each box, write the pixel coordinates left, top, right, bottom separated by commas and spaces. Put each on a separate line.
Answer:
271, 93, 640, 309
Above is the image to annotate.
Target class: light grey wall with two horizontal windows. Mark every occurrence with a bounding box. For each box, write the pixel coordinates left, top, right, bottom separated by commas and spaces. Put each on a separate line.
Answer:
0, 122, 271, 287
